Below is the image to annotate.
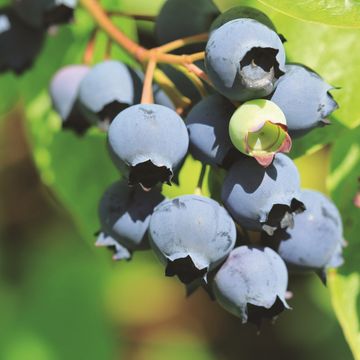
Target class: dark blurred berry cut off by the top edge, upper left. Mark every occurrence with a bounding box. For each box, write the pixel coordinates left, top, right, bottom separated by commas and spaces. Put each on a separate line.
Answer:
13, 0, 77, 28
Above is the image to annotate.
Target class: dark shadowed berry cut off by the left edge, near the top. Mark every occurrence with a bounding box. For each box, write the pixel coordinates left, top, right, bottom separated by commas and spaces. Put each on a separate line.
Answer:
0, 8, 44, 75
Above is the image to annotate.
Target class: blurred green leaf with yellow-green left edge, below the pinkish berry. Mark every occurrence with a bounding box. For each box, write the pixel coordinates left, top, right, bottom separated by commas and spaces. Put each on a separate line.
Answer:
27, 92, 120, 243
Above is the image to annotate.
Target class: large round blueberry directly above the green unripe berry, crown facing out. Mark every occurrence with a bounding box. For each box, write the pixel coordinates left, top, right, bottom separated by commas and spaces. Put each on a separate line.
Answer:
205, 19, 285, 101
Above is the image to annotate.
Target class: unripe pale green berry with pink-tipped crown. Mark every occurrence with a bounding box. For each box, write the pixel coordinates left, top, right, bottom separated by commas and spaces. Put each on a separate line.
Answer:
229, 99, 292, 167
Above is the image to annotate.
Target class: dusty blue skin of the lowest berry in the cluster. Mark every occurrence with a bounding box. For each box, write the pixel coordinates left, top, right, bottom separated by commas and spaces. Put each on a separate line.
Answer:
213, 246, 289, 323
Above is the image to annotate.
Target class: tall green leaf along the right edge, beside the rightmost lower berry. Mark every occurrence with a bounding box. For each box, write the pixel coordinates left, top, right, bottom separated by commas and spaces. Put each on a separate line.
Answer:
327, 127, 360, 359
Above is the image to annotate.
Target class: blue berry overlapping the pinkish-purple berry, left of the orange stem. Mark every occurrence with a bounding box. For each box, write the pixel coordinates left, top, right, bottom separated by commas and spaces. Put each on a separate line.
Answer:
79, 60, 135, 128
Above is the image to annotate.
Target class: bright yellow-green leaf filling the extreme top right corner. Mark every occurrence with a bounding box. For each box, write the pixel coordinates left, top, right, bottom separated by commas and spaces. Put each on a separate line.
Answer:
259, 0, 360, 28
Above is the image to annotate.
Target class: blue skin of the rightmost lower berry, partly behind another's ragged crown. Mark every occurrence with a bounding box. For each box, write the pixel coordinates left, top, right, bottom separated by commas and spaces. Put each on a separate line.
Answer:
278, 190, 344, 271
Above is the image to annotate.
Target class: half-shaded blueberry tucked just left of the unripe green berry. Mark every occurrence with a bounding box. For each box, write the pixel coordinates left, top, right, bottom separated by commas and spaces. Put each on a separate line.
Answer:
185, 94, 236, 165
